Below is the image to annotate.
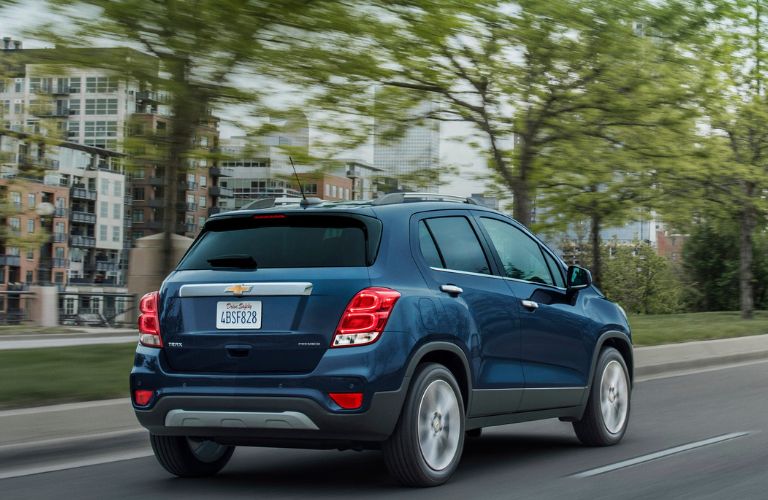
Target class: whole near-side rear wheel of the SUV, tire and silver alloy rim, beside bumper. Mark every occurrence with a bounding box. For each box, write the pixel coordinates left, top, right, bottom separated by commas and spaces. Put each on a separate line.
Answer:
382, 363, 465, 487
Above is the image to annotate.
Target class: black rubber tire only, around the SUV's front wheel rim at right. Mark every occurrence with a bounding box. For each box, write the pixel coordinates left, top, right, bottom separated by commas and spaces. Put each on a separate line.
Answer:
573, 347, 632, 446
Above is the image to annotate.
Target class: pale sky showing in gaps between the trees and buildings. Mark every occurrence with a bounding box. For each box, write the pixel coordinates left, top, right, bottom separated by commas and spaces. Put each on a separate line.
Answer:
0, 0, 488, 196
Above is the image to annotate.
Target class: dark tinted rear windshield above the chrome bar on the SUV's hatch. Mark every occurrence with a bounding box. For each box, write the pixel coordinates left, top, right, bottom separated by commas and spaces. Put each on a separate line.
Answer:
177, 214, 381, 270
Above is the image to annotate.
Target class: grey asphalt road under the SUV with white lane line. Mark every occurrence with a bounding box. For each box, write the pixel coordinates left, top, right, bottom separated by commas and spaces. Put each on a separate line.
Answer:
0, 362, 768, 500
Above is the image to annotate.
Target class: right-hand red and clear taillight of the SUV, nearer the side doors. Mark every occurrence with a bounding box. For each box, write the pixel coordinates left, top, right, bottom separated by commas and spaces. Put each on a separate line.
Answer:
331, 288, 400, 347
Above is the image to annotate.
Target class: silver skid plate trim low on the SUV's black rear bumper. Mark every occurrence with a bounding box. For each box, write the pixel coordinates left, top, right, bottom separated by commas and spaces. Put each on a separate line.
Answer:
165, 410, 318, 431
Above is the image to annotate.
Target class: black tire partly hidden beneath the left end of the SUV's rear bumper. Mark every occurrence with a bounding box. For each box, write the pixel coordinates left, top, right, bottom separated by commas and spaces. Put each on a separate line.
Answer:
149, 434, 235, 477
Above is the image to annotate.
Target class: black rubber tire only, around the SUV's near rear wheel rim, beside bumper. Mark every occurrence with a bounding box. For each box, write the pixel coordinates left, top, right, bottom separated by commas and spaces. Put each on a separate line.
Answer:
382, 363, 465, 487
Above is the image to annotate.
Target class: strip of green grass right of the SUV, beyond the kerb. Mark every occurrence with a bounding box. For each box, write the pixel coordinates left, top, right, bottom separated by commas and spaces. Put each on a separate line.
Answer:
629, 311, 768, 346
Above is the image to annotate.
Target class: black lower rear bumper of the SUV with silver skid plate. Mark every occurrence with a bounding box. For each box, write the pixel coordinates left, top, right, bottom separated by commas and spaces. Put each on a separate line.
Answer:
135, 383, 408, 448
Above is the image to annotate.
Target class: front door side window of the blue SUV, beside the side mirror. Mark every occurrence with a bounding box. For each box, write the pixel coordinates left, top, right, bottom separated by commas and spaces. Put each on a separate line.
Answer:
480, 217, 554, 285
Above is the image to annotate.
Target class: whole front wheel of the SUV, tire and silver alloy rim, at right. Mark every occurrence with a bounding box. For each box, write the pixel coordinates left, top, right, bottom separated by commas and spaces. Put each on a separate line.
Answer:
573, 347, 631, 446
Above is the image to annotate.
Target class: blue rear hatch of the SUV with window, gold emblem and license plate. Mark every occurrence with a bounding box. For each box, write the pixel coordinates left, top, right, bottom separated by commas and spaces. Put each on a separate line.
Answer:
160, 212, 381, 374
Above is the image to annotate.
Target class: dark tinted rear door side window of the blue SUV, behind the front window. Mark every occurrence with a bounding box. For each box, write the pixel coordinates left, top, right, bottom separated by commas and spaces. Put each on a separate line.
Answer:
427, 217, 490, 274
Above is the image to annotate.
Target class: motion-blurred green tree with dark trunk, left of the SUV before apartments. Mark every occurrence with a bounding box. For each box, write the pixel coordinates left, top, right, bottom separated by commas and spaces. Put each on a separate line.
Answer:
42, 0, 366, 271
